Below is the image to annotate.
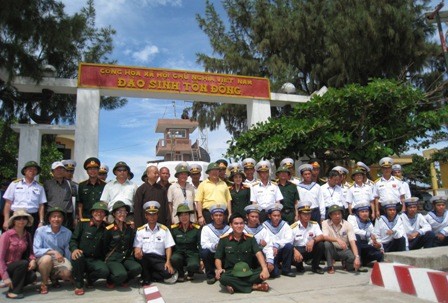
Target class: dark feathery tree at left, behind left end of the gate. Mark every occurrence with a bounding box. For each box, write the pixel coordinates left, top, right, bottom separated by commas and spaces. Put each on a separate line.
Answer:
0, 0, 126, 123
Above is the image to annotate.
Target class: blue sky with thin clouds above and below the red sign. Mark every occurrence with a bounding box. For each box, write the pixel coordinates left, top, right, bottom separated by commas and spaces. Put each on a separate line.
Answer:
63, 0, 230, 182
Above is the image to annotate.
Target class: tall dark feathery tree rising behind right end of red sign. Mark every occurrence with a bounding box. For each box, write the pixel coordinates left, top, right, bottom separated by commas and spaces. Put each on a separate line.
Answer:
192, 0, 440, 136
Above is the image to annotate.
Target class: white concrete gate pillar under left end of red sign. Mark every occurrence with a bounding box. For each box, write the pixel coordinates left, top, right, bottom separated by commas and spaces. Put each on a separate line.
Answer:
73, 88, 100, 182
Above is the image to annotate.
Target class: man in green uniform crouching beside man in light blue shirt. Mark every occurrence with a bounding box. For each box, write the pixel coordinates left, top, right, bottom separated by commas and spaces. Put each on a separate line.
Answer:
69, 202, 109, 295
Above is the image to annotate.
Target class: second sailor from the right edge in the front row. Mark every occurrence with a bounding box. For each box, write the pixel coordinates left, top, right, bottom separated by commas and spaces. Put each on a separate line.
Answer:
401, 197, 435, 250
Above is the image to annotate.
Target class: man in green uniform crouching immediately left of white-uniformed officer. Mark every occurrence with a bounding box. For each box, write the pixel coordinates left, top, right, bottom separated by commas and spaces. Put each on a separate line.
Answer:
104, 201, 142, 289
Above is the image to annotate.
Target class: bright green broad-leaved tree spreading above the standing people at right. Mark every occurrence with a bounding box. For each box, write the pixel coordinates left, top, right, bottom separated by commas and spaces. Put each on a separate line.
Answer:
228, 79, 448, 164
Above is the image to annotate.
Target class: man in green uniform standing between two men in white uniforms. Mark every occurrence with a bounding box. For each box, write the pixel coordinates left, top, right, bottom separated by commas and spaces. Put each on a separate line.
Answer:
276, 166, 299, 225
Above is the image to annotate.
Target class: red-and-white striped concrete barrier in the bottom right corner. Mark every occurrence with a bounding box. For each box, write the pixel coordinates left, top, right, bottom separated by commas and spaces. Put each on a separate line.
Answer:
370, 263, 448, 302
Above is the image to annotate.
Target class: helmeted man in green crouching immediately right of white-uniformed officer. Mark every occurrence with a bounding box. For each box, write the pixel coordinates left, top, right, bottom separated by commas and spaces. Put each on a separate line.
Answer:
171, 204, 200, 282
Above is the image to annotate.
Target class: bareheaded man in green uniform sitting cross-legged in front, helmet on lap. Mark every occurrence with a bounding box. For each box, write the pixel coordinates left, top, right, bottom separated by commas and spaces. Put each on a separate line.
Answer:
215, 214, 269, 294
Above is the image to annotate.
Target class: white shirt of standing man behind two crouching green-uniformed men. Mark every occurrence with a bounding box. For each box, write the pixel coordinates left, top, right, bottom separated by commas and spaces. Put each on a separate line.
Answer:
100, 179, 138, 212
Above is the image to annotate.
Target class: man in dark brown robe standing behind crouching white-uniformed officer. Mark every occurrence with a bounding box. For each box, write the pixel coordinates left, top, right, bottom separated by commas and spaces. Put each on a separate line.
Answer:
134, 165, 171, 227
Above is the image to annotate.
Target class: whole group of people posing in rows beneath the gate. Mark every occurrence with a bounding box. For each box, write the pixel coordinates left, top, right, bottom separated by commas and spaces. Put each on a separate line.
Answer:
0, 157, 448, 299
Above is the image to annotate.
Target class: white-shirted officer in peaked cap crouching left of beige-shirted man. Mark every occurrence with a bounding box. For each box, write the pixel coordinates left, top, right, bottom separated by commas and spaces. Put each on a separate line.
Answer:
291, 205, 325, 275
